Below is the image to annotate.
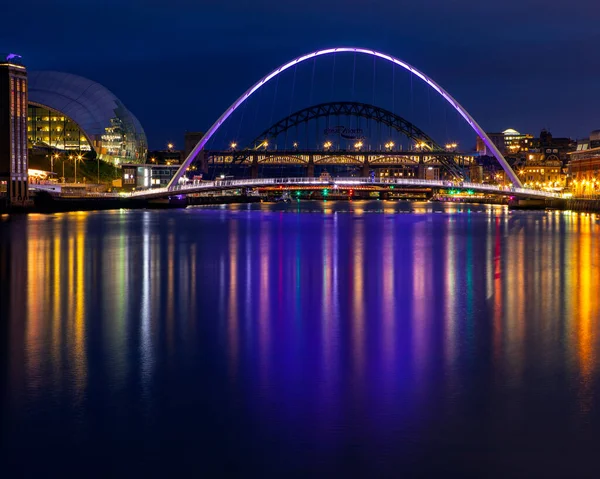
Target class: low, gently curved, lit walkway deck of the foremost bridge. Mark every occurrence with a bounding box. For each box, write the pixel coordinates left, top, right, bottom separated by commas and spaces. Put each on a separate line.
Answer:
127, 177, 563, 199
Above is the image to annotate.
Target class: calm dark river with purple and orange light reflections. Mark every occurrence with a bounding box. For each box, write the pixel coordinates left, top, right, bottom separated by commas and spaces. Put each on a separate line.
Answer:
0, 202, 600, 478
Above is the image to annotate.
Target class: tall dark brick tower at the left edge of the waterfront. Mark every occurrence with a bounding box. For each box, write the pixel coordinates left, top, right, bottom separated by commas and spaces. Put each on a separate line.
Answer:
0, 54, 29, 205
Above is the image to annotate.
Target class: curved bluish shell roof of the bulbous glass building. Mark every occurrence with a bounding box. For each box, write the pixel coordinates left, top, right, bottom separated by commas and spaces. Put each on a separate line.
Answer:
28, 71, 148, 161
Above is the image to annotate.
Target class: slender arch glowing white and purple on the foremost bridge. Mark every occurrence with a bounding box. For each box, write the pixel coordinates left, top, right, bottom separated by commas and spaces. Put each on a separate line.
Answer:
168, 47, 523, 188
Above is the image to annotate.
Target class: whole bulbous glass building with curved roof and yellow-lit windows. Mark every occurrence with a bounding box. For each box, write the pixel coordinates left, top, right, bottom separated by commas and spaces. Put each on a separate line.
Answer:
27, 71, 148, 165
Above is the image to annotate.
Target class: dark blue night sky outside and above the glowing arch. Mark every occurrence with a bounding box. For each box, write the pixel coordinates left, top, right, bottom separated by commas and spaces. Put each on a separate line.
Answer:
0, 0, 600, 148
